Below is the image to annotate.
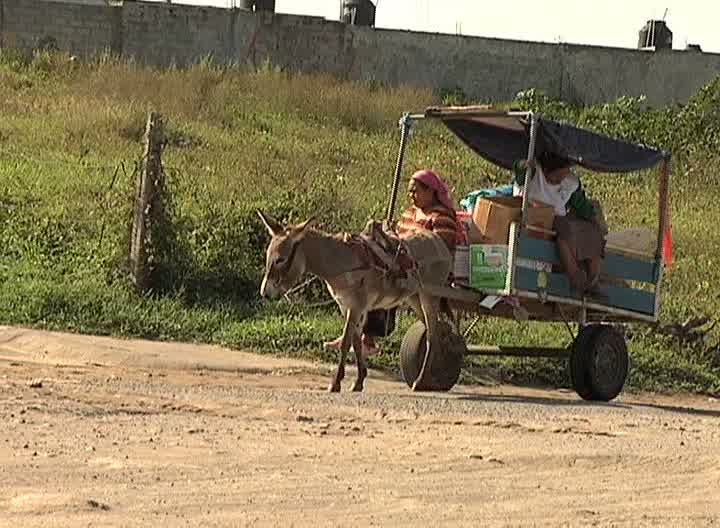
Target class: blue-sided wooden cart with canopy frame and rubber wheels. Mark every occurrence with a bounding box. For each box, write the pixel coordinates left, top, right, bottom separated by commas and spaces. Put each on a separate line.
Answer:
386, 106, 671, 401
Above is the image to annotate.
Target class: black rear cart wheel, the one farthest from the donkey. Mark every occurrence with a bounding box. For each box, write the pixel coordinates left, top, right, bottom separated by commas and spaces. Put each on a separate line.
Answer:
570, 325, 628, 401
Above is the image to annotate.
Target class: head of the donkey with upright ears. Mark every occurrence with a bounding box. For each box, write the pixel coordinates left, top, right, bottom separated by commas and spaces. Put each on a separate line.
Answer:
257, 210, 312, 299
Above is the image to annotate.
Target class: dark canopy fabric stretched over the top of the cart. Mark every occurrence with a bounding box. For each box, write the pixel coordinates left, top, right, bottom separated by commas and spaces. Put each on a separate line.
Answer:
438, 114, 669, 172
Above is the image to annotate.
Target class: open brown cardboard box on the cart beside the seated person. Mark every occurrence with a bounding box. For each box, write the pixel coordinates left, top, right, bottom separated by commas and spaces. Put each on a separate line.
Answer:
473, 196, 555, 244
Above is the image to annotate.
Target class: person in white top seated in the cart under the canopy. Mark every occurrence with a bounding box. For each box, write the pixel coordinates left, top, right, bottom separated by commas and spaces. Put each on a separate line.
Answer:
513, 153, 607, 294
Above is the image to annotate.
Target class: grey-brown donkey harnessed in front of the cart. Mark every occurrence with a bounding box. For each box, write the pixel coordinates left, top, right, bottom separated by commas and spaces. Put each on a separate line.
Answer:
257, 210, 452, 392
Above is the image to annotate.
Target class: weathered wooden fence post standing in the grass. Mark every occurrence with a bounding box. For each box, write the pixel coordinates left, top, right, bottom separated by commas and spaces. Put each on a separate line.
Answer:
130, 112, 164, 292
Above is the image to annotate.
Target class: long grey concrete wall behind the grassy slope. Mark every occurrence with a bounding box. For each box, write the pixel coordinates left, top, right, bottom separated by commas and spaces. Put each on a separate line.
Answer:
0, 0, 720, 105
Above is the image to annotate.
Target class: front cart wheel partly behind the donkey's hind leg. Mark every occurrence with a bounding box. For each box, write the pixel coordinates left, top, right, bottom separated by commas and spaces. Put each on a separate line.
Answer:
400, 321, 467, 391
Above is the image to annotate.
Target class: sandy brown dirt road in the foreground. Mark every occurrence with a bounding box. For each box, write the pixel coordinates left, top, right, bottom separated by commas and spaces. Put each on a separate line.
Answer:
0, 327, 720, 527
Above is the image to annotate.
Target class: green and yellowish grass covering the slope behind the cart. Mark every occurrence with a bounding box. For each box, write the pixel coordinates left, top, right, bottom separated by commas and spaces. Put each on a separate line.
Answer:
0, 51, 720, 393
